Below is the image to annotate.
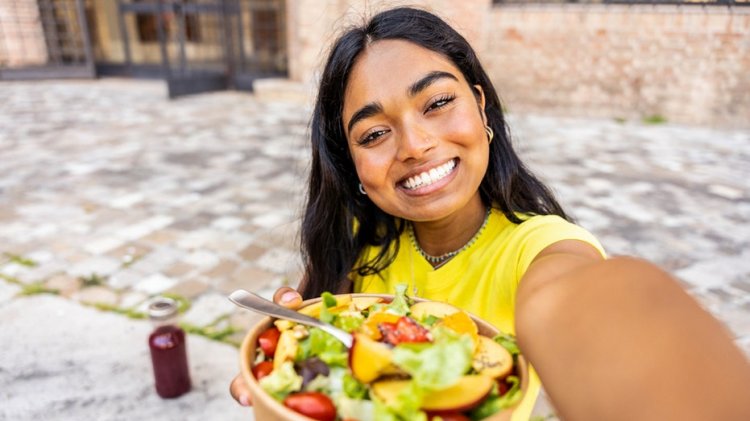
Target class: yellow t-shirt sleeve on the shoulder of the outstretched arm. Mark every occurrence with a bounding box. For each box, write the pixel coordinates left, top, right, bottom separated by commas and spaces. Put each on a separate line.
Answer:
516, 215, 606, 281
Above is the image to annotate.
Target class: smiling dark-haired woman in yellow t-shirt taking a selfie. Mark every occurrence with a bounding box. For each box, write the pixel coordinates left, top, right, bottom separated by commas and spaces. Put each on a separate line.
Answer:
232, 8, 750, 420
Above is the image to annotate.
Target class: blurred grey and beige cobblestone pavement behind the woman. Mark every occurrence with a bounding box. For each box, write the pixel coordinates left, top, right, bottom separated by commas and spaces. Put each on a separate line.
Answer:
0, 79, 750, 416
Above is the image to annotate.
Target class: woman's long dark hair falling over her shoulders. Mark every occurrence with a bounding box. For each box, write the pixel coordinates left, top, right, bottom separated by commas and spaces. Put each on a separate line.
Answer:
301, 8, 568, 298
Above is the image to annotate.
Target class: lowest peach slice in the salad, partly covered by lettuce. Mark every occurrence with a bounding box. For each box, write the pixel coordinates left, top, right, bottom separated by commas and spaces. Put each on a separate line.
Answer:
372, 374, 493, 412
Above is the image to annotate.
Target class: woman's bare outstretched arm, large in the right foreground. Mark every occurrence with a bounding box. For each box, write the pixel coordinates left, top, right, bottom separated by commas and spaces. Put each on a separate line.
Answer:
516, 249, 750, 421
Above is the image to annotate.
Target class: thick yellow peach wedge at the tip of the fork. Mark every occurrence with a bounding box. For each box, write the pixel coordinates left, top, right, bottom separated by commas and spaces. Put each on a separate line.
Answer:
349, 332, 393, 383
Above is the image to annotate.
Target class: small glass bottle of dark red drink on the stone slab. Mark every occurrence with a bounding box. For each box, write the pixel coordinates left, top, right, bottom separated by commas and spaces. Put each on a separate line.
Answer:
148, 298, 190, 398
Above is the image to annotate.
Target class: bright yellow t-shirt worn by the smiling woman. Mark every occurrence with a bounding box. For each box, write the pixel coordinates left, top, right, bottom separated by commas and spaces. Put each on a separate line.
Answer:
353, 209, 605, 420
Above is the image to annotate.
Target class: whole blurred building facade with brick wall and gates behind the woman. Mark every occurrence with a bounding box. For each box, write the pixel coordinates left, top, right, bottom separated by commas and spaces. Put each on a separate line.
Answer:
0, 0, 750, 127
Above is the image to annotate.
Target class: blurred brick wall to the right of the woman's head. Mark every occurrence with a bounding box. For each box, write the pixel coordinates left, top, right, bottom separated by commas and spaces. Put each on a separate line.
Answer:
482, 5, 750, 127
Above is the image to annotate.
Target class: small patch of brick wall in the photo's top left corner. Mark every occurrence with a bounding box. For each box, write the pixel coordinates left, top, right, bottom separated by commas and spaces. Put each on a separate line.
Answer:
0, 0, 47, 67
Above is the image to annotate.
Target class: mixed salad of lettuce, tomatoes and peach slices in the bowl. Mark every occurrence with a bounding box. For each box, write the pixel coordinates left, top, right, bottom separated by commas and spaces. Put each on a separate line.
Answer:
252, 286, 521, 421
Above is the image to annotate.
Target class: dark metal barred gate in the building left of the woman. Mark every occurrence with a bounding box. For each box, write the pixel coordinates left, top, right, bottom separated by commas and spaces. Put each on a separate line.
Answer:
117, 0, 287, 96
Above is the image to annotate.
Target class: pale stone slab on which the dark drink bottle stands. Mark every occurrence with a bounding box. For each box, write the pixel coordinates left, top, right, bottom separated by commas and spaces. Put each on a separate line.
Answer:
0, 288, 253, 421
